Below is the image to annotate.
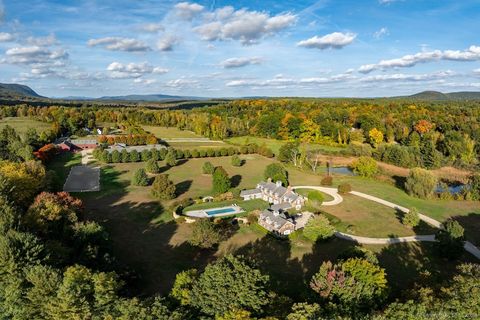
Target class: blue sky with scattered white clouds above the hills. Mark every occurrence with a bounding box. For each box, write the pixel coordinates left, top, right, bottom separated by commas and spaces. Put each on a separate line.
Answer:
0, 0, 480, 97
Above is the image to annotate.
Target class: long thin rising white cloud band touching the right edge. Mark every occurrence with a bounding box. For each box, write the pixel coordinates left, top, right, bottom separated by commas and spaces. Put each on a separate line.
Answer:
358, 46, 480, 73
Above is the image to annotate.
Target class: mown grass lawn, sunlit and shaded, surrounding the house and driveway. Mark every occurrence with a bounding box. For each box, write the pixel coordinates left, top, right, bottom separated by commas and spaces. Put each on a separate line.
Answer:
48, 155, 478, 299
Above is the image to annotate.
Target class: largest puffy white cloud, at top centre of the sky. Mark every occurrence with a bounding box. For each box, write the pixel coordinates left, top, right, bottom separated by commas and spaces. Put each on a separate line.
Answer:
194, 6, 297, 45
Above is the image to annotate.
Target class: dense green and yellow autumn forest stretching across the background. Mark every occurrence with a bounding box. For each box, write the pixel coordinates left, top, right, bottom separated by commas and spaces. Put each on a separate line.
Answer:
0, 99, 480, 169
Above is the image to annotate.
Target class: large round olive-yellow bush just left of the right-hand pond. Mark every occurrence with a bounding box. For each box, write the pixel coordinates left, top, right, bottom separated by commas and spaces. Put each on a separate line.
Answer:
405, 168, 438, 199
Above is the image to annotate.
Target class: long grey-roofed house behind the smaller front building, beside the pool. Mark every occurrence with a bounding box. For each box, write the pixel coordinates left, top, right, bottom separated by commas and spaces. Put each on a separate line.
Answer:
240, 179, 306, 210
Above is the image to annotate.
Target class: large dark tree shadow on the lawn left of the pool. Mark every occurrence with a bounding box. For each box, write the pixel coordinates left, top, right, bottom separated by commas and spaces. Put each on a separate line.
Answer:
79, 166, 218, 295
